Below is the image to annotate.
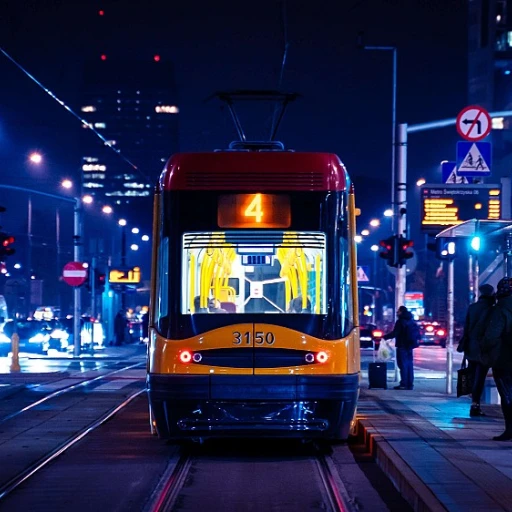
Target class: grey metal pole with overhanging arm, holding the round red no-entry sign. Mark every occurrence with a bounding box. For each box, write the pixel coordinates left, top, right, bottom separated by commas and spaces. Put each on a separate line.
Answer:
0, 185, 83, 356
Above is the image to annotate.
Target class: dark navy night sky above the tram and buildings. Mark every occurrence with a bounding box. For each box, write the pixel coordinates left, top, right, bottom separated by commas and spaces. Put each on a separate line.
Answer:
0, 0, 467, 244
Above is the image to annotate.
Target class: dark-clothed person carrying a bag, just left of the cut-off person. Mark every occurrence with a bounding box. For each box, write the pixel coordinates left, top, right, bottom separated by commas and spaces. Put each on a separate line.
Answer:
457, 284, 496, 417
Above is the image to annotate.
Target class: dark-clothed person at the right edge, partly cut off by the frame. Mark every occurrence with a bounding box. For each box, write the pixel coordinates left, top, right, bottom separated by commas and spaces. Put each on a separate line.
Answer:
480, 277, 512, 441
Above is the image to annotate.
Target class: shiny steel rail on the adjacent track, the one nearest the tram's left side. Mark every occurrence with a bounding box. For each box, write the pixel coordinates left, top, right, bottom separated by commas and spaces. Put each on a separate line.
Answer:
0, 387, 146, 500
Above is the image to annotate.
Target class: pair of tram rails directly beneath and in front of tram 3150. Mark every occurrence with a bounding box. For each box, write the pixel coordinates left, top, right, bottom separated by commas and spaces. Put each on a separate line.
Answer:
144, 446, 358, 512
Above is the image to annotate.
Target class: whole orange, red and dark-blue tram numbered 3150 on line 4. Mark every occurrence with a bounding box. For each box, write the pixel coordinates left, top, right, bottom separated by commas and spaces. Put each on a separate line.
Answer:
147, 148, 360, 439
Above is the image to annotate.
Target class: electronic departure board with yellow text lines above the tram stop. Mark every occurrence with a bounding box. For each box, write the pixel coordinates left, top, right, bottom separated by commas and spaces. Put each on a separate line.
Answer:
421, 184, 501, 233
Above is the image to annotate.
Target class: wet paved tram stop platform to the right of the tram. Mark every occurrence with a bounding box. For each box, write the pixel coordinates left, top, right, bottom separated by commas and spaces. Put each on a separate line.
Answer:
355, 377, 512, 512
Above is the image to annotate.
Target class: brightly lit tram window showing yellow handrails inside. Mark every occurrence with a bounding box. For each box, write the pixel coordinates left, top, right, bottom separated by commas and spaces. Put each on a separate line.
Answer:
181, 231, 327, 315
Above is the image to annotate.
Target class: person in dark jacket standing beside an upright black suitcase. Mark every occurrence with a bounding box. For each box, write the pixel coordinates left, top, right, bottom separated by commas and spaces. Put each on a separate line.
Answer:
383, 306, 420, 389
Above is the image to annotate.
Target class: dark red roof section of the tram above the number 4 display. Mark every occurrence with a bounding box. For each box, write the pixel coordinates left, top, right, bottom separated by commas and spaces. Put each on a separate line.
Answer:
160, 151, 350, 191
